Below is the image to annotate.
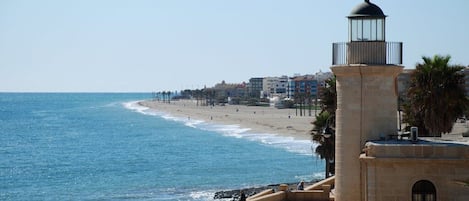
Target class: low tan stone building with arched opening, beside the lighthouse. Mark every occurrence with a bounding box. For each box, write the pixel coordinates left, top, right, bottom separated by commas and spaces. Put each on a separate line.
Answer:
360, 143, 469, 201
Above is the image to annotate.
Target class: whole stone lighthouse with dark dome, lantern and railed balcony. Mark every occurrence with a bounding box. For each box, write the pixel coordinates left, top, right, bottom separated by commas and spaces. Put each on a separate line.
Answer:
331, 0, 403, 201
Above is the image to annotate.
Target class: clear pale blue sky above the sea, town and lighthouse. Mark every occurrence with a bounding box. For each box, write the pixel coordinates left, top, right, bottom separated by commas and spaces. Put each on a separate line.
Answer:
0, 0, 469, 92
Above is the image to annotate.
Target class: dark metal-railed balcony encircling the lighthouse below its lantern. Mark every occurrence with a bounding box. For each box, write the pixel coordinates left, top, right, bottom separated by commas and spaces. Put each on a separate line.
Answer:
332, 41, 402, 65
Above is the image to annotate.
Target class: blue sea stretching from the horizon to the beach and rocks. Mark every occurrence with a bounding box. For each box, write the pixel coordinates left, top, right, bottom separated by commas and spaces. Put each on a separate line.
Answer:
0, 93, 324, 201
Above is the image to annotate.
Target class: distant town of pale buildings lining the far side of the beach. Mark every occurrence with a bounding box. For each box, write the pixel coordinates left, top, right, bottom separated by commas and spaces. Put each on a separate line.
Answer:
152, 66, 469, 108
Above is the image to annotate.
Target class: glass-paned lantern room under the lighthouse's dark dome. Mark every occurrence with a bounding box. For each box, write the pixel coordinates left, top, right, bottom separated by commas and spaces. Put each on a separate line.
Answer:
349, 18, 384, 41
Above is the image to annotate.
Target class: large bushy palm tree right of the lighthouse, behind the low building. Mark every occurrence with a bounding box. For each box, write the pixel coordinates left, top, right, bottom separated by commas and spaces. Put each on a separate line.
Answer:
404, 55, 469, 137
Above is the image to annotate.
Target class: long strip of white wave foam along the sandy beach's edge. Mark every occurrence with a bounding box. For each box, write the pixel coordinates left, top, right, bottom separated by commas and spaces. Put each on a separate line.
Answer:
123, 101, 317, 155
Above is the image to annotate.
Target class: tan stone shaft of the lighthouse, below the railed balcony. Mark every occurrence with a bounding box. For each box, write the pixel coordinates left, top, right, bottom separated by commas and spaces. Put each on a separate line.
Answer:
331, 65, 403, 201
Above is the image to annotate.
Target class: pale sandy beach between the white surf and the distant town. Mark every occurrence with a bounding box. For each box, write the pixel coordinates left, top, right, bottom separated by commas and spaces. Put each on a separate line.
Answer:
139, 100, 314, 140
